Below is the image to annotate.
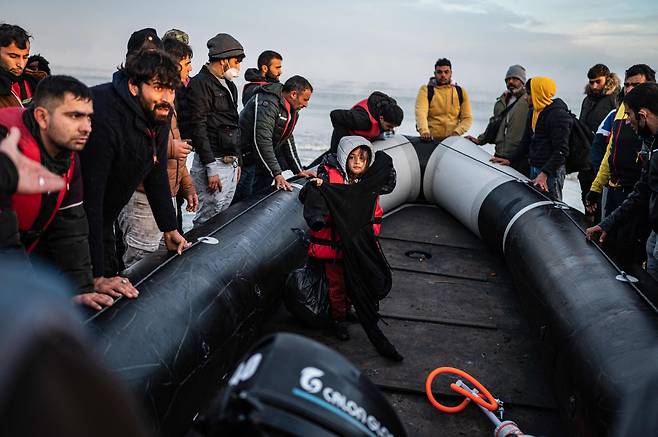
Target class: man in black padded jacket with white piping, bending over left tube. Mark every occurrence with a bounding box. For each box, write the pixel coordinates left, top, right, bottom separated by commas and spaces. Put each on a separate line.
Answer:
236, 76, 314, 201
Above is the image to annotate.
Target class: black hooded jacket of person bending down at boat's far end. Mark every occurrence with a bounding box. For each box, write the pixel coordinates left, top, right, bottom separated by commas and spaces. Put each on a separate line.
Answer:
329, 91, 397, 152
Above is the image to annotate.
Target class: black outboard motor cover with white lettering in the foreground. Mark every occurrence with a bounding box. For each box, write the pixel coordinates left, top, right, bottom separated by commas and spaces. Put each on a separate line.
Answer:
192, 333, 406, 437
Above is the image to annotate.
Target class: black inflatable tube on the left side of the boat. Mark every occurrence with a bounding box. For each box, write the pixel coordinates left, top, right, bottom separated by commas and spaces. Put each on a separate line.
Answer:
86, 185, 306, 435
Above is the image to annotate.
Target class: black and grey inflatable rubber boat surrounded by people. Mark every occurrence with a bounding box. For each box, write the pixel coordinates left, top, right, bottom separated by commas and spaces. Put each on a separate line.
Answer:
85, 135, 658, 436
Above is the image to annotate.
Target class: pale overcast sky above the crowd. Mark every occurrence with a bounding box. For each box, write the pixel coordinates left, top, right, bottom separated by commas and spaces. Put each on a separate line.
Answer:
2, 0, 658, 98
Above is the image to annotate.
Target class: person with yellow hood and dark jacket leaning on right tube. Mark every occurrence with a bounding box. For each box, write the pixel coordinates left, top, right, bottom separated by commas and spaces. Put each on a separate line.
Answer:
514, 77, 573, 200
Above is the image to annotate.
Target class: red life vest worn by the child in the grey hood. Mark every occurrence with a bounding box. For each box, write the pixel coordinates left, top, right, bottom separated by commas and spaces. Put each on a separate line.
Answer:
308, 164, 384, 259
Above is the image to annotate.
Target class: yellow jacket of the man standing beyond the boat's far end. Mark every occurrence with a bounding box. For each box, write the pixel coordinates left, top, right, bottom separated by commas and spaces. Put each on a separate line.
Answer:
416, 85, 473, 140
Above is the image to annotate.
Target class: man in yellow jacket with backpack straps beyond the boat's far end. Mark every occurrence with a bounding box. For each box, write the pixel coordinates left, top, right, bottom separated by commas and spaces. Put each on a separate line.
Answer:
416, 58, 473, 141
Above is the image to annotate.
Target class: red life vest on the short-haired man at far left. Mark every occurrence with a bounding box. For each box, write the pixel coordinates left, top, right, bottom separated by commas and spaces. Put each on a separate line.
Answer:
0, 108, 75, 253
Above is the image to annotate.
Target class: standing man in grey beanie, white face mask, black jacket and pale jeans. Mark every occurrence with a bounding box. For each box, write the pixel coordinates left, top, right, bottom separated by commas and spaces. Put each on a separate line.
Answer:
178, 33, 244, 225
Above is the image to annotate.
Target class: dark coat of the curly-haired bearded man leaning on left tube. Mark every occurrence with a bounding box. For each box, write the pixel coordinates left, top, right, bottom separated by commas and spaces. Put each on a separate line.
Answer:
80, 71, 176, 277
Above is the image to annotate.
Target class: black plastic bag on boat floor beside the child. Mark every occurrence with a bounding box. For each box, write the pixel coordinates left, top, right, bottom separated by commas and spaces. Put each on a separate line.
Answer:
283, 258, 331, 328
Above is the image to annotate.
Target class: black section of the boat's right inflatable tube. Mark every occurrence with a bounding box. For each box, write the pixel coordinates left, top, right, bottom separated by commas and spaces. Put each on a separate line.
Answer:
478, 181, 658, 436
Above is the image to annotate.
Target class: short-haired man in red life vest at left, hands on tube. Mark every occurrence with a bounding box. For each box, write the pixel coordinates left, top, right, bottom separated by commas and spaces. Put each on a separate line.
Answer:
0, 76, 136, 309
